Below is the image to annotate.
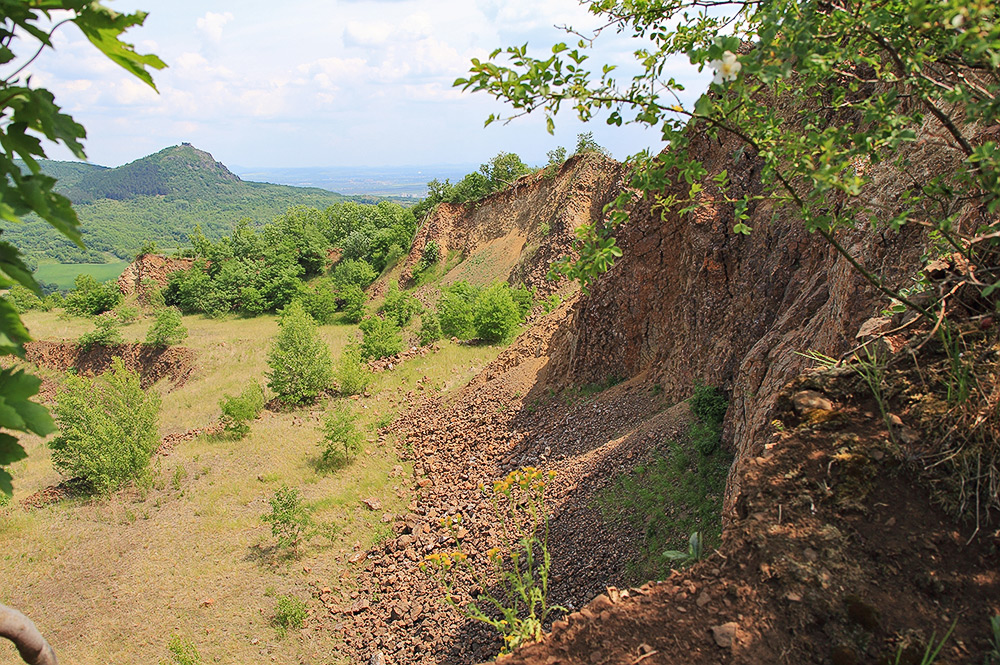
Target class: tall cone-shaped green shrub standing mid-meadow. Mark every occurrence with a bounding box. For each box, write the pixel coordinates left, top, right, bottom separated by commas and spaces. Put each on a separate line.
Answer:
267, 301, 333, 404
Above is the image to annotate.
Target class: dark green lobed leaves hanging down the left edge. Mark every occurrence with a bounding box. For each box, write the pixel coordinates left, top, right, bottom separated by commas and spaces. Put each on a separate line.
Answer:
0, 0, 165, 495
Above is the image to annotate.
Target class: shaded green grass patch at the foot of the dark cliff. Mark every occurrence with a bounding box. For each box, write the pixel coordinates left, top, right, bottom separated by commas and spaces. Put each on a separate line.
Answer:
597, 427, 732, 582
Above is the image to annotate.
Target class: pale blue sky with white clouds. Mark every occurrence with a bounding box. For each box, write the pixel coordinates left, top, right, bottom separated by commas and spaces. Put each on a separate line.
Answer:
13, 0, 710, 167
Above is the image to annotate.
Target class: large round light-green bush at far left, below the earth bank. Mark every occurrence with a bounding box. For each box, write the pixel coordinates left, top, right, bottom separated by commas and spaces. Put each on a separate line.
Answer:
49, 358, 160, 493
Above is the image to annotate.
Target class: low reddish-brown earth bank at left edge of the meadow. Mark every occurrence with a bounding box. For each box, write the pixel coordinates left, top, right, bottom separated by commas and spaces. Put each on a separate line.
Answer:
25, 340, 195, 389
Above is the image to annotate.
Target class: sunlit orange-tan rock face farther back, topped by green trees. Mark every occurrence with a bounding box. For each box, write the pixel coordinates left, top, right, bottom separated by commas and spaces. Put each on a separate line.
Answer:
399, 153, 623, 295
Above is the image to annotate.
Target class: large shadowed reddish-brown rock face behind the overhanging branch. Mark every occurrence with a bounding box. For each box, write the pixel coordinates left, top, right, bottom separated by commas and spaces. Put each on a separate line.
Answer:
549, 123, 956, 503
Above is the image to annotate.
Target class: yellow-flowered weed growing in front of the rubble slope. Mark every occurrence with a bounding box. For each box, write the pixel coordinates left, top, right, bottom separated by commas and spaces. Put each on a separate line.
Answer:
420, 467, 565, 654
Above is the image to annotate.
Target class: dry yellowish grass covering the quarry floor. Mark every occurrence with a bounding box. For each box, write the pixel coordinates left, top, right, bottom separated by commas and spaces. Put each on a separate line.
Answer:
0, 306, 499, 665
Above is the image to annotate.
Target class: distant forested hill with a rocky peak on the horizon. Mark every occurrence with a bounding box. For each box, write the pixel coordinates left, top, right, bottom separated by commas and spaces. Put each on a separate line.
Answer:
9, 143, 380, 263
